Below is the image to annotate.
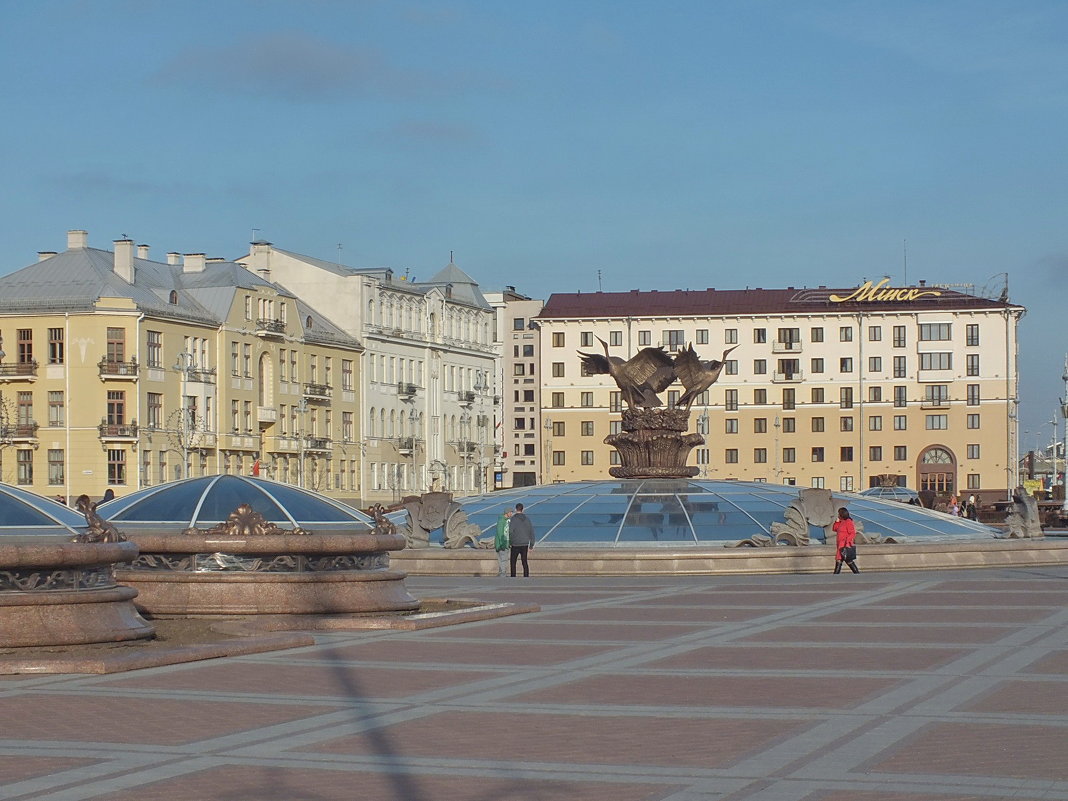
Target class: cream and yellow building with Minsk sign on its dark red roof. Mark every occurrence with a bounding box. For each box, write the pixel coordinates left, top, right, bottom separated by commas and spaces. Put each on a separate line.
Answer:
537, 280, 1024, 499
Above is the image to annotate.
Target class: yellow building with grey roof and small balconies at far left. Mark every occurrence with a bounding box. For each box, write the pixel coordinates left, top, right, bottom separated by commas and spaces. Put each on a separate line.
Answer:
0, 231, 362, 502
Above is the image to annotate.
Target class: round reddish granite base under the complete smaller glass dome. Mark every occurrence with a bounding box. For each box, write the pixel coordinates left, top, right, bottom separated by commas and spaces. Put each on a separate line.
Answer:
116, 532, 419, 615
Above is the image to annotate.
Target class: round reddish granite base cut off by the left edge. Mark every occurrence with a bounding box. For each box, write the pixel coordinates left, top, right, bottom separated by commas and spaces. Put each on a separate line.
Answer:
0, 543, 154, 647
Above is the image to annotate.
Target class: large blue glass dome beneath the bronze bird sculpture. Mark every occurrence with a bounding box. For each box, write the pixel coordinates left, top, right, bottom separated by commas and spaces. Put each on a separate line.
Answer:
429, 478, 999, 546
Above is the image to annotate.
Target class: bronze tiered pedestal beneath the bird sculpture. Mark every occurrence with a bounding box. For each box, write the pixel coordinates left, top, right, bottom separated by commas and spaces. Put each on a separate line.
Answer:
604, 408, 705, 478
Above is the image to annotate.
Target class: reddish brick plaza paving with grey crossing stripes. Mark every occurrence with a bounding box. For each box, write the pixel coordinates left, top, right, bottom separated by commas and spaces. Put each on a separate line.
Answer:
0, 552, 1068, 801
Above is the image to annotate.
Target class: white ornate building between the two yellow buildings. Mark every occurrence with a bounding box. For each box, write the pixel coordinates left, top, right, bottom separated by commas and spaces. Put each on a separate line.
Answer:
237, 241, 500, 503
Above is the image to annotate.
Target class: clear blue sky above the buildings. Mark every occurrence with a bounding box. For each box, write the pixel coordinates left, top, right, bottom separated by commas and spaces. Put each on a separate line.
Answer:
0, 0, 1068, 446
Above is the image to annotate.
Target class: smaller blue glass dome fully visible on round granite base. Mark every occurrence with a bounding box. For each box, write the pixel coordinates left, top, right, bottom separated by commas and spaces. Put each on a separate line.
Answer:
97, 475, 374, 534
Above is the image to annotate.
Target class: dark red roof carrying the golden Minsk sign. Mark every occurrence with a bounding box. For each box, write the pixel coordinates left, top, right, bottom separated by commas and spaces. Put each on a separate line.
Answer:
538, 285, 1019, 319
